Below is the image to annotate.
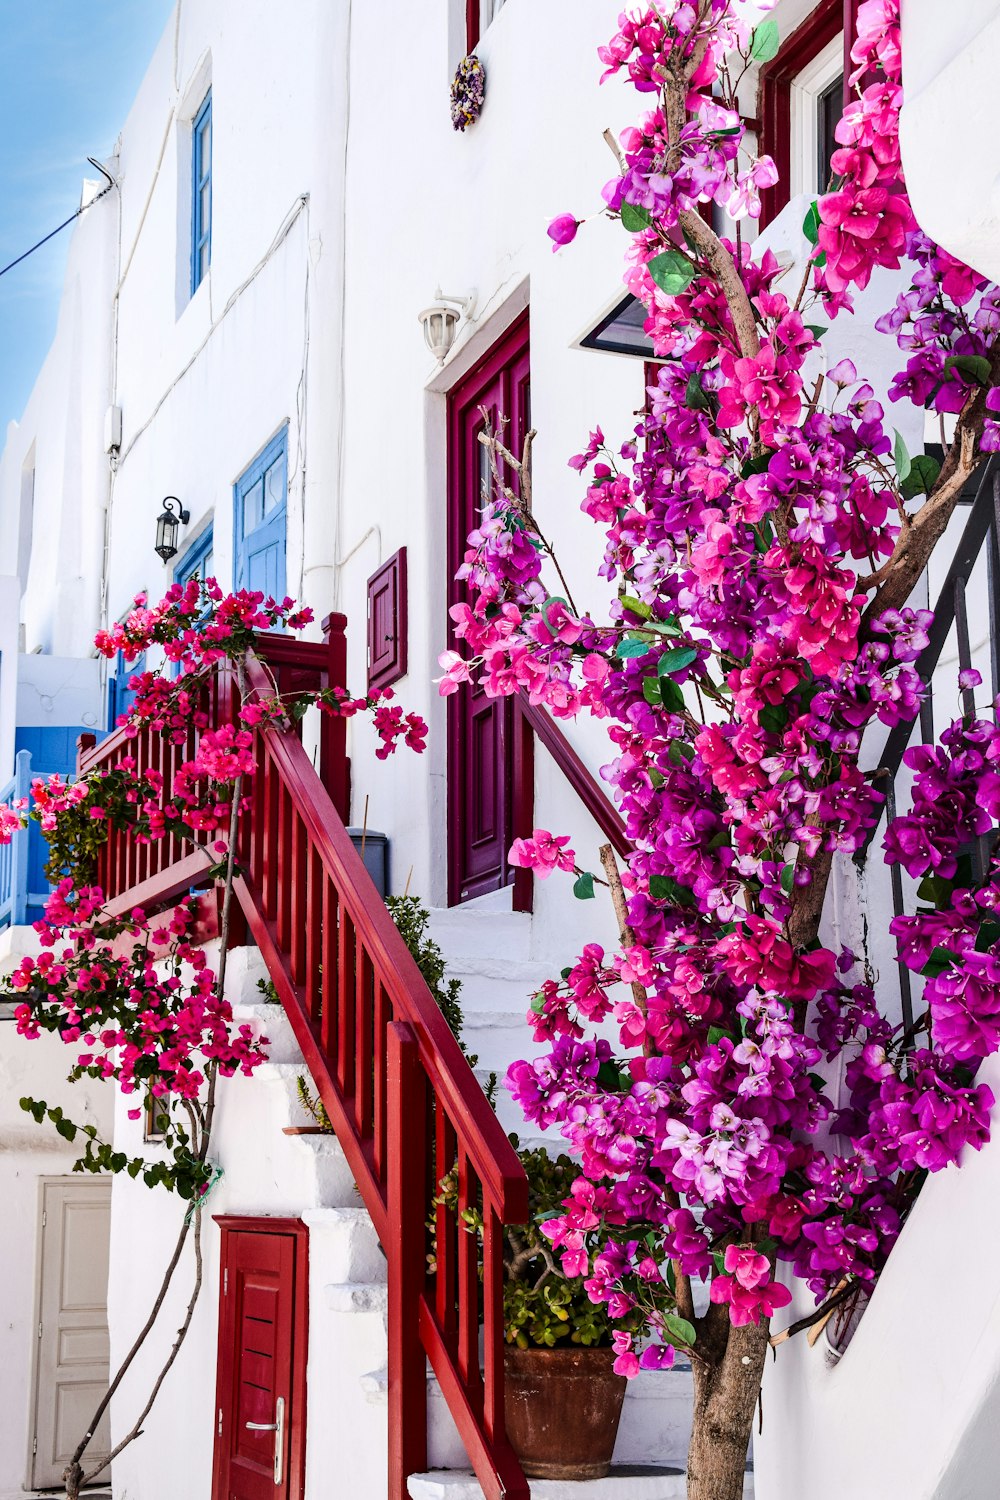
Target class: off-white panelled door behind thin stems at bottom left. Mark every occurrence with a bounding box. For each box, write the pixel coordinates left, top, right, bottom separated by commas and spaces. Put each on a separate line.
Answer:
28, 1178, 111, 1490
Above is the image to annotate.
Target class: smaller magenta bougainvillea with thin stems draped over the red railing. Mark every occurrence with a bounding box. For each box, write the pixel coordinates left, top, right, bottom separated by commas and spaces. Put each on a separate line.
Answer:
0, 579, 427, 1500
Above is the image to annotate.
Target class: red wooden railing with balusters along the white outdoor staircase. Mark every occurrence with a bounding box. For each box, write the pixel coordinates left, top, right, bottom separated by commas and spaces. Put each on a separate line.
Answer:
81, 638, 529, 1500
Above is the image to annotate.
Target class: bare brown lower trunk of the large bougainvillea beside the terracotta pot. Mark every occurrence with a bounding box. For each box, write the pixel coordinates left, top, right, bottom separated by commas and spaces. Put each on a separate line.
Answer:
688, 1307, 768, 1500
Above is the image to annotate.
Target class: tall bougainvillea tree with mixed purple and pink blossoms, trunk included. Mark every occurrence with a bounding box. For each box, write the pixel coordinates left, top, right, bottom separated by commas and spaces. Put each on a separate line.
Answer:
441, 0, 1000, 1500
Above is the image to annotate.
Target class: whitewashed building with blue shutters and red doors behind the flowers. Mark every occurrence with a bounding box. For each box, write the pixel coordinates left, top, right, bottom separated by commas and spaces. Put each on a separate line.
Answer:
0, 0, 1000, 1500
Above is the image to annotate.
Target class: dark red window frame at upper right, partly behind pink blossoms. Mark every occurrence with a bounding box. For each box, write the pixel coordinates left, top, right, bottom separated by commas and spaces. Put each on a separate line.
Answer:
757, 0, 861, 230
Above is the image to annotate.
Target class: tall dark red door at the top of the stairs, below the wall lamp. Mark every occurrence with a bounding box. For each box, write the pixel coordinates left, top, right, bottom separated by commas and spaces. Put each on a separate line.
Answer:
448, 312, 531, 906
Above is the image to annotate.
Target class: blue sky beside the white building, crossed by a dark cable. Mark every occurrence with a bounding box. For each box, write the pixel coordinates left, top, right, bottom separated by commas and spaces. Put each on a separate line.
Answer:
0, 0, 172, 435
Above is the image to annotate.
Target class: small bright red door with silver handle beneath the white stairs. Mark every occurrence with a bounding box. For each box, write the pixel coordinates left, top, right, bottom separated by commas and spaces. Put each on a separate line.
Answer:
211, 1218, 307, 1500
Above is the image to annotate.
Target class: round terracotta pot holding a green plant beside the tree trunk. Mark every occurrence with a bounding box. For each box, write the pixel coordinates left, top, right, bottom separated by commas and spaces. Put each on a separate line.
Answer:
504, 1344, 625, 1479
